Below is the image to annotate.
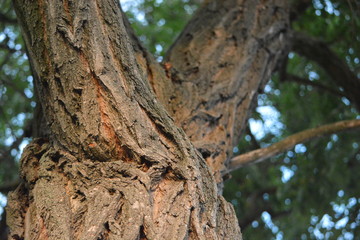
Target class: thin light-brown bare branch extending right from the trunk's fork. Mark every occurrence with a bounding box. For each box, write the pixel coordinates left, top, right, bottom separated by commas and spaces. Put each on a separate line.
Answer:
229, 119, 360, 171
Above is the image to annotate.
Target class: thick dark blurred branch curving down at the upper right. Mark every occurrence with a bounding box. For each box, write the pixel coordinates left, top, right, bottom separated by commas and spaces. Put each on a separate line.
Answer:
290, 31, 360, 111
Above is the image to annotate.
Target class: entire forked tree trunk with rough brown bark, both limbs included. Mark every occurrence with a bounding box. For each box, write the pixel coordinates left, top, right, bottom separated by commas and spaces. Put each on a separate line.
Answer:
7, 0, 288, 240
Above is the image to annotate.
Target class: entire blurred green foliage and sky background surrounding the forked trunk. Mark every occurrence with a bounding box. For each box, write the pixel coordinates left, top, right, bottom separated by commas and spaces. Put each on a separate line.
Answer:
0, 0, 360, 240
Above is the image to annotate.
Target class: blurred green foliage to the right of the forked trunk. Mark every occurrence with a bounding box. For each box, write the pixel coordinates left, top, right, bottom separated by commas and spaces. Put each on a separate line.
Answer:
225, 1, 360, 239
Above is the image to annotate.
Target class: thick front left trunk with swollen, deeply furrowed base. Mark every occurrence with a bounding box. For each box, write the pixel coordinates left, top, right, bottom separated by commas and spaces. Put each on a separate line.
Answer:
8, 0, 241, 239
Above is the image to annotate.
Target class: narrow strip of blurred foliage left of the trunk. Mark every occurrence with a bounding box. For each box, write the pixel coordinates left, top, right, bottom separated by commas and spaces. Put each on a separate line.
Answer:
0, 0, 31, 186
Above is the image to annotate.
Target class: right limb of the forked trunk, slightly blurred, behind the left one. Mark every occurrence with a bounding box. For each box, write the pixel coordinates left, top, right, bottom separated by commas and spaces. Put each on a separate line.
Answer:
162, 0, 288, 183
